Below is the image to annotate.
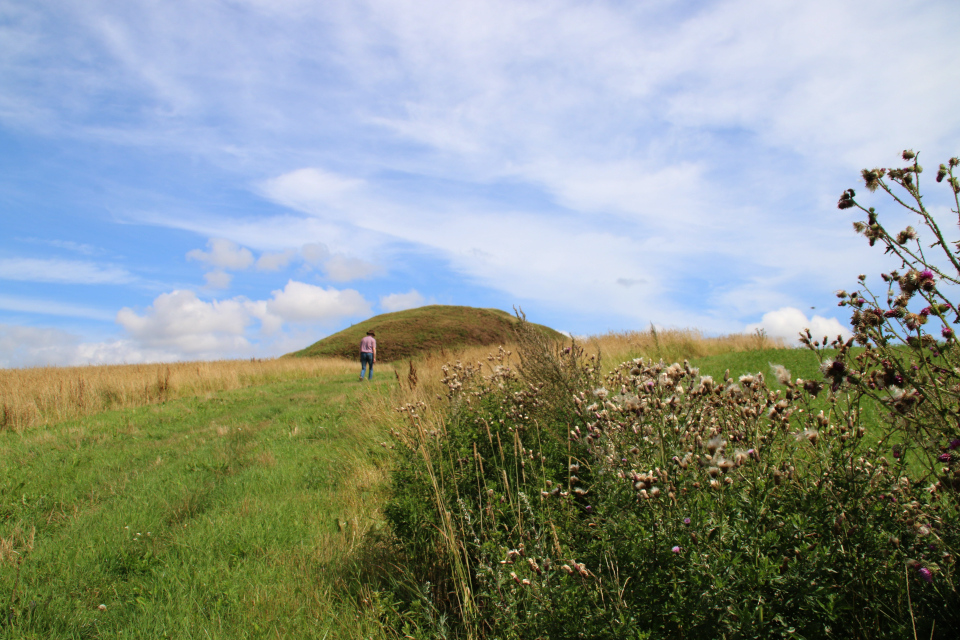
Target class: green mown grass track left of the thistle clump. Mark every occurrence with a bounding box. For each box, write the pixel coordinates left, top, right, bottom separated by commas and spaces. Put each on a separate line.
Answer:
0, 368, 395, 639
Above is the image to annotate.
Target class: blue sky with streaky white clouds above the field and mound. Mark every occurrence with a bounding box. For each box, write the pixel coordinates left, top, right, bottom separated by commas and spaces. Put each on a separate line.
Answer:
0, 0, 960, 367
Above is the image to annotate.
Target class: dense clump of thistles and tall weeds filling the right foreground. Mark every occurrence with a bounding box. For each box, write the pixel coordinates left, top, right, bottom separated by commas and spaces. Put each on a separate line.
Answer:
386, 149, 960, 638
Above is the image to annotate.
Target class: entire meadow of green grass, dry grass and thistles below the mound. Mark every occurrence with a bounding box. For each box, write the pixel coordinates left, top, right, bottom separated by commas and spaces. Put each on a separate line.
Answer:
7, 150, 960, 640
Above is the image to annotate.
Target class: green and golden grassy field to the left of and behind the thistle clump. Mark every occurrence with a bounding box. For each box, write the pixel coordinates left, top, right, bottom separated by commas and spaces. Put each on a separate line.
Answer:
0, 331, 876, 638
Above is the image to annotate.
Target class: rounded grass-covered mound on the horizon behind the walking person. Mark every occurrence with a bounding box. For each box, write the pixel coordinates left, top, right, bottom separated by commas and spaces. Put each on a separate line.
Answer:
288, 305, 563, 362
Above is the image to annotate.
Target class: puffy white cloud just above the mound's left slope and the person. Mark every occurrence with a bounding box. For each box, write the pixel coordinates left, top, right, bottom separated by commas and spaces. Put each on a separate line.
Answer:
266, 280, 371, 322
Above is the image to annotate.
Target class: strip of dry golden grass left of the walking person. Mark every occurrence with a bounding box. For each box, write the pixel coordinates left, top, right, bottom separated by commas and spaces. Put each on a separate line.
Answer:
0, 358, 357, 432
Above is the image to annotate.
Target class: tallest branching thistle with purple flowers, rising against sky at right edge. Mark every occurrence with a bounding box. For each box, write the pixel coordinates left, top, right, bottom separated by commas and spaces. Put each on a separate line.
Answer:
824, 150, 960, 480
